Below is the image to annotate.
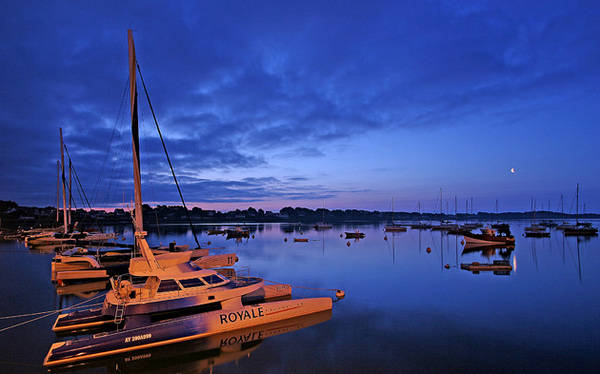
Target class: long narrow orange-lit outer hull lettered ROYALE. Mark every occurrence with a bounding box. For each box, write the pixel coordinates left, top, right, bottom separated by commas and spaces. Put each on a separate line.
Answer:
44, 298, 332, 367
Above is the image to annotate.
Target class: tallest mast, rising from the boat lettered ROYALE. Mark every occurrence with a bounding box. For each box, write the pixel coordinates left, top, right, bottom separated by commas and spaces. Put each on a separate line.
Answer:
127, 30, 144, 231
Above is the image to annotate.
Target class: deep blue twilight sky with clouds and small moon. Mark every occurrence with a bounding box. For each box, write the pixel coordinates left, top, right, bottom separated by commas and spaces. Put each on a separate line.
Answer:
0, 1, 600, 213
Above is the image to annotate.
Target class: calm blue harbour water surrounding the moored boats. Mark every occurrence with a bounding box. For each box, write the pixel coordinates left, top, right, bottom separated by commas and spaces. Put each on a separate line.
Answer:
0, 222, 600, 373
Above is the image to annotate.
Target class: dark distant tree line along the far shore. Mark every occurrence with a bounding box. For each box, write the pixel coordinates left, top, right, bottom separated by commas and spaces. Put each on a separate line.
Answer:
0, 200, 600, 229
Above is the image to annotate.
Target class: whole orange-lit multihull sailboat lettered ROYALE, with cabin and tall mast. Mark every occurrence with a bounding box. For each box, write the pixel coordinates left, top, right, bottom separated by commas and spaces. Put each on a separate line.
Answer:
44, 30, 332, 367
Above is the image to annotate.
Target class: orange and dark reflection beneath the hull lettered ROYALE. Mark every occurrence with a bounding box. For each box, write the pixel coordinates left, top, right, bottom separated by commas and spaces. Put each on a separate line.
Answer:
50, 309, 331, 373
